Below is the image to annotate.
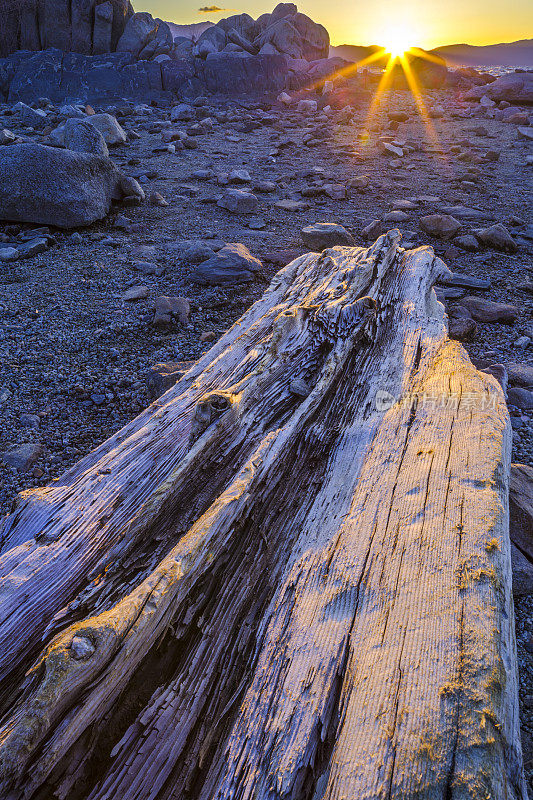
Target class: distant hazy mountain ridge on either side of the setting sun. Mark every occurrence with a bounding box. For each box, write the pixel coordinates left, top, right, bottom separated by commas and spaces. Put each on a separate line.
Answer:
330, 39, 533, 69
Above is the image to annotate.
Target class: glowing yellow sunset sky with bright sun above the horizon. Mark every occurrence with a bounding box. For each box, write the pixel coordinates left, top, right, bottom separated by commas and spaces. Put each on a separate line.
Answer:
140, 0, 533, 50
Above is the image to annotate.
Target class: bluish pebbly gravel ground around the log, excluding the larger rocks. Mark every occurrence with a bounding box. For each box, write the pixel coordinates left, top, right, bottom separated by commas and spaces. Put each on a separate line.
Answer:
0, 83, 533, 791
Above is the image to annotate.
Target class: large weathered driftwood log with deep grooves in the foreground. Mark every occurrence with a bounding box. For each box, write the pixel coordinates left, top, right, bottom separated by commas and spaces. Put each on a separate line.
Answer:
0, 231, 527, 800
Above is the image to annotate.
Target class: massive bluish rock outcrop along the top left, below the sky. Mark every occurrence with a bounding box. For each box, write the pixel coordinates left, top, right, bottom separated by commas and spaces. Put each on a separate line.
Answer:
0, 0, 330, 103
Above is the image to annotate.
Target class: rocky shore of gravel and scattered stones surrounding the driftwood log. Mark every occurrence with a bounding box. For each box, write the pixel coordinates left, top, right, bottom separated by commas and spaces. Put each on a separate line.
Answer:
0, 0, 533, 790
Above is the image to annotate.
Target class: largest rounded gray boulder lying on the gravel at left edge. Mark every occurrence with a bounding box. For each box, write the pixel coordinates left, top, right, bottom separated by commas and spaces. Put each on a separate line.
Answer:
0, 144, 122, 228
